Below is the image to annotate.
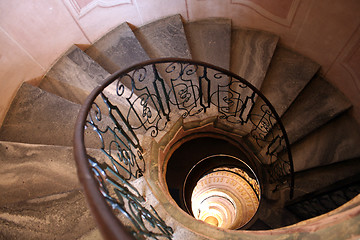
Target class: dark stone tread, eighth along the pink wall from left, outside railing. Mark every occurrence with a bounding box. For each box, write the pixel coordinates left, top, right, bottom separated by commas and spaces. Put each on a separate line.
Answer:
281, 77, 351, 143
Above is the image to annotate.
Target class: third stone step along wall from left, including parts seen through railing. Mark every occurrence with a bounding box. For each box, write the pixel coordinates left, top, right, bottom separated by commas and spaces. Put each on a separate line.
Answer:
86, 22, 176, 124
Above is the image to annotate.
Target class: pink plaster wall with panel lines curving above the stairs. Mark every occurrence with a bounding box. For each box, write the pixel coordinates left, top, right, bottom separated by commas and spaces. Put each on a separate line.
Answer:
0, 0, 360, 123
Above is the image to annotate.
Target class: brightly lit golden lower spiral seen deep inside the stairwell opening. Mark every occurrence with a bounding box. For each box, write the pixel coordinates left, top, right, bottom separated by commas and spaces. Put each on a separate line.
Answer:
191, 169, 259, 229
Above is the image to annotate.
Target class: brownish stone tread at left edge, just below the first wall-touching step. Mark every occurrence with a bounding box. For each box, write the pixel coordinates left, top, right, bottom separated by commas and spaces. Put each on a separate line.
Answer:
0, 142, 80, 206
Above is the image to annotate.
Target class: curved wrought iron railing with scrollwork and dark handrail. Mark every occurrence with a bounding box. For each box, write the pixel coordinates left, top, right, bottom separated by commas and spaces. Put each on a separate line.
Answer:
75, 58, 293, 239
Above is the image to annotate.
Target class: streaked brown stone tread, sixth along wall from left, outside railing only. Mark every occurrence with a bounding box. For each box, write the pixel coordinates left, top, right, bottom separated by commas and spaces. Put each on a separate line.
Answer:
230, 28, 279, 89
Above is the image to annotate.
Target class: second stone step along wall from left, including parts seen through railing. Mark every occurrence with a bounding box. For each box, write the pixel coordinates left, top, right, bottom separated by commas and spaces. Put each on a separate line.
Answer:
39, 46, 146, 126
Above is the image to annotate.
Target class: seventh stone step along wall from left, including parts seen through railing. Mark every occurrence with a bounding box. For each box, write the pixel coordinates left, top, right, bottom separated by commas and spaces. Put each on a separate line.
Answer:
248, 46, 319, 151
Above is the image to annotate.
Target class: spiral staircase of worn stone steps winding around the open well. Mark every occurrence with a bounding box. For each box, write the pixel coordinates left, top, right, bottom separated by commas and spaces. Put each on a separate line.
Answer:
0, 15, 360, 239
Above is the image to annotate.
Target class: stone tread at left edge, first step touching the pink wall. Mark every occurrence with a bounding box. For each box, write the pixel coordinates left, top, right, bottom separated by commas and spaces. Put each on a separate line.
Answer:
0, 83, 80, 146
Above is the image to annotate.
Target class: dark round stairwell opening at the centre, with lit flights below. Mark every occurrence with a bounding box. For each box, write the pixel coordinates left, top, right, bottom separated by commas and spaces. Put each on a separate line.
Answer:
166, 136, 262, 230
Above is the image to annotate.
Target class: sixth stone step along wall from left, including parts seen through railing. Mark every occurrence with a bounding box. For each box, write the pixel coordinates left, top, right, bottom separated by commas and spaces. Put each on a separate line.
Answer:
227, 28, 279, 131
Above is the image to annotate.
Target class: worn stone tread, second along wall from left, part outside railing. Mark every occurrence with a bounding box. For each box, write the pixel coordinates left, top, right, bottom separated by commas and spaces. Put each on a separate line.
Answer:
39, 46, 109, 104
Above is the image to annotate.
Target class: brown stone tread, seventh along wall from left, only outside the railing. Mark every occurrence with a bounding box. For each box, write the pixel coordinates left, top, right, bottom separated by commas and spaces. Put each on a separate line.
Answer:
253, 46, 320, 117
